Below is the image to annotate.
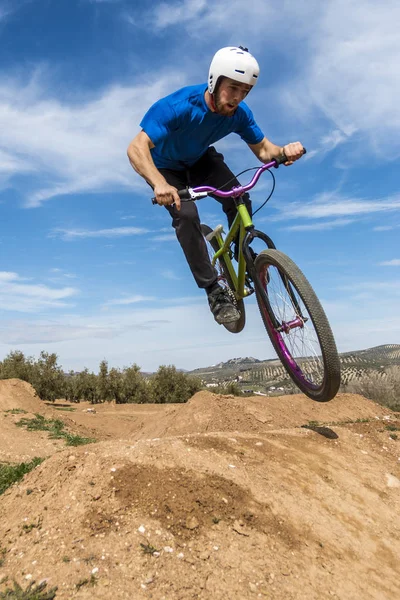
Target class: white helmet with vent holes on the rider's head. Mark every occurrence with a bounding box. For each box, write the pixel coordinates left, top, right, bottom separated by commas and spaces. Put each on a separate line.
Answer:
208, 46, 260, 94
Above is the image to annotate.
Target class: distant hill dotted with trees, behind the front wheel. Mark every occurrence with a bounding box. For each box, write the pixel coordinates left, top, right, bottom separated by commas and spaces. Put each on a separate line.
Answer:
187, 344, 400, 393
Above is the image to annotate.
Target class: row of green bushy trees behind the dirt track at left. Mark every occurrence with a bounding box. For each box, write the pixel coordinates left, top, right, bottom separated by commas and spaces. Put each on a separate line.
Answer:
0, 351, 206, 404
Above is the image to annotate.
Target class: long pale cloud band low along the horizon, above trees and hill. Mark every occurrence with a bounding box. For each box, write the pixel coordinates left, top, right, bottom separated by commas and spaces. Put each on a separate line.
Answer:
0, 296, 400, 370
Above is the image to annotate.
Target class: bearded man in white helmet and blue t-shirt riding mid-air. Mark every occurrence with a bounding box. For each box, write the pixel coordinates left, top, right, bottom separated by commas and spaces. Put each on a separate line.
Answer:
128, 46, 303, 323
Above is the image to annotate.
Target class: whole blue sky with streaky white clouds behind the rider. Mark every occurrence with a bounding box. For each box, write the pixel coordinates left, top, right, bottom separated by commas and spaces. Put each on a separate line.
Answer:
0, 0, 400, 371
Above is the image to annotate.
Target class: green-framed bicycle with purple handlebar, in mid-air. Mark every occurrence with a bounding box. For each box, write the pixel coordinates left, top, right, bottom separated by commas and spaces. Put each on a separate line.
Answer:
153, 150, 340, 402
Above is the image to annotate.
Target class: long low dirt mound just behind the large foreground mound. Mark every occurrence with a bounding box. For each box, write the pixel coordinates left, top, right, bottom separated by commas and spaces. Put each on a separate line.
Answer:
61, 391, 391, 441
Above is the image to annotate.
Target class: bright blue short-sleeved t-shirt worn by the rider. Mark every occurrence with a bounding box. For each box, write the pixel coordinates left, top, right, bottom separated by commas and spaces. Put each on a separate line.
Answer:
140, 84, 264, 170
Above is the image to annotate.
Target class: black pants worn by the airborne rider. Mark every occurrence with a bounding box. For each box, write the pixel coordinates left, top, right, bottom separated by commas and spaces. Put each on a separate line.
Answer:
159, 146, 252, 288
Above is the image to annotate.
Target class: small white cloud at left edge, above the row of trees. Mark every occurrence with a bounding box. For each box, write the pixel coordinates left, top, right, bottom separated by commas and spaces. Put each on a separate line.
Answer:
0, 271, 78, 312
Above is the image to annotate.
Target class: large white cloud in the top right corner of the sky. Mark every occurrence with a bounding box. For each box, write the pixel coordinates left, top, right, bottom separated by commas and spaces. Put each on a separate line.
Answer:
287, 0, 400, 161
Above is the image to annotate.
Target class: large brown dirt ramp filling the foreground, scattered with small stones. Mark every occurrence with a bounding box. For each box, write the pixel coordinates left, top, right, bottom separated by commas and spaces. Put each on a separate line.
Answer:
0, 427, 400, 600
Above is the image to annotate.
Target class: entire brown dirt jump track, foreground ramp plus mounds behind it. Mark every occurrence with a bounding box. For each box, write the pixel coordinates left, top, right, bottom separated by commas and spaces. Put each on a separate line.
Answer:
0, 380, 400, 600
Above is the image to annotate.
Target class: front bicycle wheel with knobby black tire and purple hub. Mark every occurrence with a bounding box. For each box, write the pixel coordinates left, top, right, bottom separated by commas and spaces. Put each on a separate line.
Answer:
255, 249, 340, 402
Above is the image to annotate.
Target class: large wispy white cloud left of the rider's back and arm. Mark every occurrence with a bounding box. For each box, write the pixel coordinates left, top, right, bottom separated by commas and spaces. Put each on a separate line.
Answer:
0, 70, 184, 207
